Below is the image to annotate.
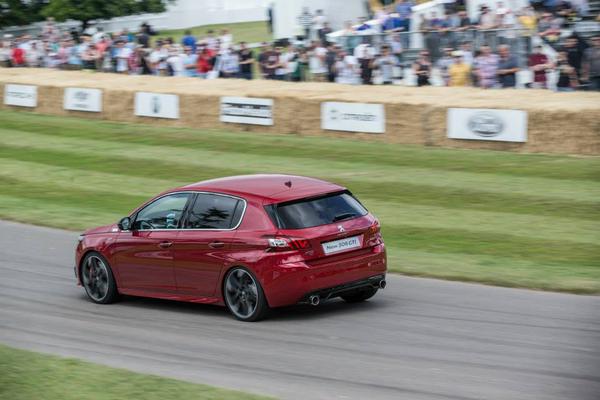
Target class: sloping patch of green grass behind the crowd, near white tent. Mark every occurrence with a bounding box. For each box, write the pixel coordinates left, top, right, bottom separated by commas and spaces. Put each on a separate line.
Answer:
155, 21, 273, 43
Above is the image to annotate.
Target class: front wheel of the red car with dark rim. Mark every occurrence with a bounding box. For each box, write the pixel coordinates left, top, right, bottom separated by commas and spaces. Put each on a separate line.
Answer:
79, 252, 119, 304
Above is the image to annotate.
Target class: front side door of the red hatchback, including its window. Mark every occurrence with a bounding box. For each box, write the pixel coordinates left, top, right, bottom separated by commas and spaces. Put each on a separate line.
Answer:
114, 193, 192, 292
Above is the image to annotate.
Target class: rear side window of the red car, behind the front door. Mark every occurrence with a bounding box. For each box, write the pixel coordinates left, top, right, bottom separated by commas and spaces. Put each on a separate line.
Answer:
185, 193, 244, 229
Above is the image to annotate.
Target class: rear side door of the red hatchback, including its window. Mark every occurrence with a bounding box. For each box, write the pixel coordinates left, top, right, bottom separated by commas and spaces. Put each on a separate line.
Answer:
173, 193, 246, 297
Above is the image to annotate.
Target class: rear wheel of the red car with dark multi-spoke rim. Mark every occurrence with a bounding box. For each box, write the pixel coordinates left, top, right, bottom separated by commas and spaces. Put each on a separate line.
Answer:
223, 267, 269, 322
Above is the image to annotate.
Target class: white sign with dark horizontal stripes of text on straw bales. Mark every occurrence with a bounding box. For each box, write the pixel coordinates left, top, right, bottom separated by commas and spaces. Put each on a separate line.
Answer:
221, 97, 273, 125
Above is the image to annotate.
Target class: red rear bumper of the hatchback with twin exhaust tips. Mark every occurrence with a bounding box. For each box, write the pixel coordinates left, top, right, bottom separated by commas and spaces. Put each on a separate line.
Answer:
261, 245, 387, 307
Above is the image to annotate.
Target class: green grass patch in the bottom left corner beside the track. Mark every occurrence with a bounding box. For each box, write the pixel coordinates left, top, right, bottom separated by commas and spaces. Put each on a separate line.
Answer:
0, 345, 266, 400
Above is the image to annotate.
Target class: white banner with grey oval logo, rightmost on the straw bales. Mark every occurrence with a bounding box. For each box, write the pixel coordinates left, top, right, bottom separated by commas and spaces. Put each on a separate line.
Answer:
447, 108, 527, 142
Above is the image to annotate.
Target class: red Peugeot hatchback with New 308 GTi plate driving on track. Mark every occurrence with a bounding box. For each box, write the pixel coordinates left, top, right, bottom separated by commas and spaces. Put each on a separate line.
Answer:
75, 175, 387, 321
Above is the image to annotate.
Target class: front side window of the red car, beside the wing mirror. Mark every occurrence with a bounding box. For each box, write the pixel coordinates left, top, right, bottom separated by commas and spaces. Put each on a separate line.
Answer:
133, 193, 190, 230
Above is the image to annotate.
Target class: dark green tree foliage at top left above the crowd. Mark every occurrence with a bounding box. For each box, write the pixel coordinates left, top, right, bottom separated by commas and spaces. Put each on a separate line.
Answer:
42, 0, 175, 30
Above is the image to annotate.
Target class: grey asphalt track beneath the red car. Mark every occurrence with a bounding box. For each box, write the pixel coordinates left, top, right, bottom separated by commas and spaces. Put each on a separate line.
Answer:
0, 221, 600, 400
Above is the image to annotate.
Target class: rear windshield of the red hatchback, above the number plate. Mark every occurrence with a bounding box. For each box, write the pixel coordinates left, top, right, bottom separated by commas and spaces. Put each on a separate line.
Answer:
267, 192, 367, 229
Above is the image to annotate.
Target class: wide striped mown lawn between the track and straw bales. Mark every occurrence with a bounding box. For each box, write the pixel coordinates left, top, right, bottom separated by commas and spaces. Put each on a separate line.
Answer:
0, 111, 600, 293
